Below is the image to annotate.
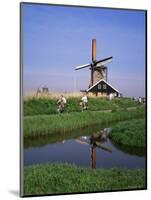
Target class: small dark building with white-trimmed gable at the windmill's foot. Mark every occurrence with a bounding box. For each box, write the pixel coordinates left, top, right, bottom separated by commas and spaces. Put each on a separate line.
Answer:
86, 79, 120, 97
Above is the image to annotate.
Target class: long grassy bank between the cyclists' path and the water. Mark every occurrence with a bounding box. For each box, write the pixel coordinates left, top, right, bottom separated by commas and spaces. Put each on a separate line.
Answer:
24, 107, 145, 138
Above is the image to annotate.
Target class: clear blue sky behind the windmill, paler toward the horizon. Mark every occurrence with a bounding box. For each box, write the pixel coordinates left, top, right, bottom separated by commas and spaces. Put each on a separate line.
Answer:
22, 4, 145, 96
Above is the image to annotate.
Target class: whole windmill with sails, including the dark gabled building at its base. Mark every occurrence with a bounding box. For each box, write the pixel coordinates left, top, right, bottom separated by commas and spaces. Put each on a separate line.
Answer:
75, 39, 119, 96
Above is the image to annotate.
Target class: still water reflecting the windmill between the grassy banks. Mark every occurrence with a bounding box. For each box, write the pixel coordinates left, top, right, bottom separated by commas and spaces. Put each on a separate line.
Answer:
24, 126, 145, 168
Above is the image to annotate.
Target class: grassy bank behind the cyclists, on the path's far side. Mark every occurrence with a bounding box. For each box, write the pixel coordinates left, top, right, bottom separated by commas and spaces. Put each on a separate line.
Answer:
24, 97, 138, 116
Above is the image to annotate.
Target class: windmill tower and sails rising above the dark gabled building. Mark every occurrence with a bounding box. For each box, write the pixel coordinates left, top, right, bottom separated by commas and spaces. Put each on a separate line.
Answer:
75, 39, 113, 87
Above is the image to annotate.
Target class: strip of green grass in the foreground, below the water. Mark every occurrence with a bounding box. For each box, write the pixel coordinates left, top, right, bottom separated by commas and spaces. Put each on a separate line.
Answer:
24, 163, 146, 195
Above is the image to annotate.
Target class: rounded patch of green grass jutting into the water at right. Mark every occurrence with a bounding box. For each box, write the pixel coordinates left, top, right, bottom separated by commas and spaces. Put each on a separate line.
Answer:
110, 119, 146, 147
